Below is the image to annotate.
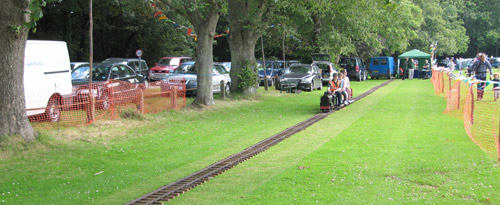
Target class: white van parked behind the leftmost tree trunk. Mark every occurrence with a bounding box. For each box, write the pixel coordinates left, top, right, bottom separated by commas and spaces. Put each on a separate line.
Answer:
24, 40, 72, 122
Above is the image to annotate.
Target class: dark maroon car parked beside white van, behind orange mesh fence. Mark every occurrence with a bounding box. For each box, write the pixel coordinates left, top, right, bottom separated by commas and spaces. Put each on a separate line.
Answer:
71, 63, 146, 110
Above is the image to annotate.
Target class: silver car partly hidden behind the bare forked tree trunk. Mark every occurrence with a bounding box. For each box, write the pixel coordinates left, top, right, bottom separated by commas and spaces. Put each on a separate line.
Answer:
166, 61, 231, 96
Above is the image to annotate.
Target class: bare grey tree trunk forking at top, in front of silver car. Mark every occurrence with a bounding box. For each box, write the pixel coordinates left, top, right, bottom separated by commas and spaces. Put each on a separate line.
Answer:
162, 0, 221, 105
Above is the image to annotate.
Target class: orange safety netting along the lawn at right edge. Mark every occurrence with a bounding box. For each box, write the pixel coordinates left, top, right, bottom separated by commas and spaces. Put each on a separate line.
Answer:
432, 71, 500, 161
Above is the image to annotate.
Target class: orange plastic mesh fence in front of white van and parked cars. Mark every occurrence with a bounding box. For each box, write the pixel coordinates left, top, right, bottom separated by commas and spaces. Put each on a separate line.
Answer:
26, 78, 186, 129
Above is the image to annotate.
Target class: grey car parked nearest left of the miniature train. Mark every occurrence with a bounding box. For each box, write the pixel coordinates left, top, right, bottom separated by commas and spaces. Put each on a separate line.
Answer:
280, 64, 323, 91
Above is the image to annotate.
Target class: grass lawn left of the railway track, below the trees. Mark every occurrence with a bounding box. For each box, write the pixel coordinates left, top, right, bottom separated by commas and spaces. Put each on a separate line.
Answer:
0, 80, 383, 204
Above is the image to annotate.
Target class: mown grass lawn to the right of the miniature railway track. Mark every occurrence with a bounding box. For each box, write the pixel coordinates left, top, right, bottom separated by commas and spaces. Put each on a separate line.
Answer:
172, 80, 500, 204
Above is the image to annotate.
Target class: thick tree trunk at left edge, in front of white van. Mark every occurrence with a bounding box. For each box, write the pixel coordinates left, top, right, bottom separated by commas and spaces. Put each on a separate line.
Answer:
0, 0, 37, 141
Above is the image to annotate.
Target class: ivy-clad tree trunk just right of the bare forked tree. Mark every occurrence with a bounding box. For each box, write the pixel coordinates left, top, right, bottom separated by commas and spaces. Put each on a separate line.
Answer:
228, 0, 267, 94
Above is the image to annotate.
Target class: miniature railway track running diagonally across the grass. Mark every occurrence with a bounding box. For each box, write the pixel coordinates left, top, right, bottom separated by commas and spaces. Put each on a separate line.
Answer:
127, 80, 392, 204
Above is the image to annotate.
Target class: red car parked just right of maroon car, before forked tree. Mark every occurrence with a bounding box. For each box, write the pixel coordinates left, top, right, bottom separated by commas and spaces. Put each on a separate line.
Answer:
149, 57, 193, 81
